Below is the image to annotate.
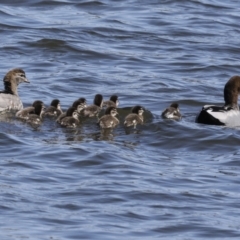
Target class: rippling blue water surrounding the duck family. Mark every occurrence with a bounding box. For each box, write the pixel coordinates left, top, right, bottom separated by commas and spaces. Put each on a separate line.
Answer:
0, 0, 240, 240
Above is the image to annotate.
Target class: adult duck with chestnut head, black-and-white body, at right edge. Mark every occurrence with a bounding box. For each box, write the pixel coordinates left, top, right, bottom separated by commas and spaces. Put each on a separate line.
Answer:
196, 76, 240, 127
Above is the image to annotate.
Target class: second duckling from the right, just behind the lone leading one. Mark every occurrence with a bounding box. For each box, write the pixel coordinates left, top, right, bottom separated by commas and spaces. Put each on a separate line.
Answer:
124, 105, 144, 128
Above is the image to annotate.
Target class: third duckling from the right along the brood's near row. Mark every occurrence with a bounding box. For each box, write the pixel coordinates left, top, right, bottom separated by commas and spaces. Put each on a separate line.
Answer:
98, 107, 119, 129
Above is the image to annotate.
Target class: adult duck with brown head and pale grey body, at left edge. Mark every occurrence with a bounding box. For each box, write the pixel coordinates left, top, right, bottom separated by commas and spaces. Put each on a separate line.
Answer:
0, 68, 29, 112
